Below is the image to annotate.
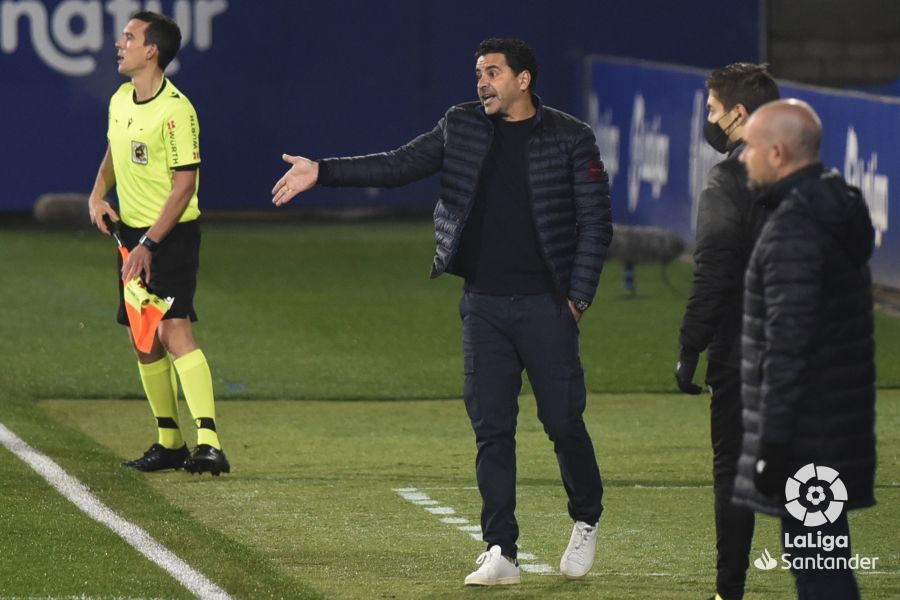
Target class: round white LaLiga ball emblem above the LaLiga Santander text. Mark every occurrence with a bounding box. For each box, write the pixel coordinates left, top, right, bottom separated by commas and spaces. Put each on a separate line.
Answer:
784, 463, 847, 527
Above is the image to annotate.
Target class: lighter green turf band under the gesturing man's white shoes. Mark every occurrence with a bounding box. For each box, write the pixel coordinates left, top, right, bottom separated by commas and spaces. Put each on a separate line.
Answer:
33, 391, 900, 600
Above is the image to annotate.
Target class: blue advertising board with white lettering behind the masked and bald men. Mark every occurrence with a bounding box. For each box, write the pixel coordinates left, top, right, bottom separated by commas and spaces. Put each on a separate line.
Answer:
587, 57, 900, 288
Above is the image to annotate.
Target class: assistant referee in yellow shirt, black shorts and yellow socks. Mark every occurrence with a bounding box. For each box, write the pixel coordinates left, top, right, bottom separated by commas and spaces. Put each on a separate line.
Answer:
90, 11, 231, 475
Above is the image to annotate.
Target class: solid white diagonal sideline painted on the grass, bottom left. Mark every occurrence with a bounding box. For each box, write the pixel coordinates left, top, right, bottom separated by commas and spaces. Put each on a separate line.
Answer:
0, 423, 231, 600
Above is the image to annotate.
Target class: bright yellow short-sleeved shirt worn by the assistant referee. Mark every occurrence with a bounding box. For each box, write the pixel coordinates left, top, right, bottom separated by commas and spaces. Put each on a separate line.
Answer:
106, 79, 200, 227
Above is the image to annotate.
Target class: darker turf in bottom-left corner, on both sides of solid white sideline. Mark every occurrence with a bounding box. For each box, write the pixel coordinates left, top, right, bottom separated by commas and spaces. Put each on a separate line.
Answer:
0, 401, 320, 598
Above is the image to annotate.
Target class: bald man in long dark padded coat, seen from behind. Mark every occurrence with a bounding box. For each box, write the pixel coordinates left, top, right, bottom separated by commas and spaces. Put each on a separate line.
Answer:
734, 100, 875, 600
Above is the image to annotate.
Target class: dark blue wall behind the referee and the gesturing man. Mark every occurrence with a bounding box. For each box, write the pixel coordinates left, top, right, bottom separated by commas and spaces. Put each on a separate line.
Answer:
0, 0, 760, 211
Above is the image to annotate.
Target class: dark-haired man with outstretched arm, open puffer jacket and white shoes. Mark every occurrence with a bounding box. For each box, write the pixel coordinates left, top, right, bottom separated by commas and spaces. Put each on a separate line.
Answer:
273, 39, 612, 586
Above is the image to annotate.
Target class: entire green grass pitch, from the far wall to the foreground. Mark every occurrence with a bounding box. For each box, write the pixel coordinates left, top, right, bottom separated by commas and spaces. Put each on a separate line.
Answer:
0, 223, 900, 599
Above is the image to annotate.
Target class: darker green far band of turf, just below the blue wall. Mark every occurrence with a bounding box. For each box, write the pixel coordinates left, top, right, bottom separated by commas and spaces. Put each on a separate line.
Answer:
0, 222, 900, 399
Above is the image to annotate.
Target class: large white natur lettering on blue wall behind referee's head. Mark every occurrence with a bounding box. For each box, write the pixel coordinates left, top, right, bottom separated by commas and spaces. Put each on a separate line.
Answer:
0, 0, 228, 76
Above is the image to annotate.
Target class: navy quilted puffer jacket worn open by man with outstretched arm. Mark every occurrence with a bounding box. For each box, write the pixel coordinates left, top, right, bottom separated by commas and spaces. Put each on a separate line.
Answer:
318, 96, 612, 302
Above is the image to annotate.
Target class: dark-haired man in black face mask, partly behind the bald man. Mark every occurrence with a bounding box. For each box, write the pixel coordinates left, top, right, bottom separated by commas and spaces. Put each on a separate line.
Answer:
675, 63, 779, 600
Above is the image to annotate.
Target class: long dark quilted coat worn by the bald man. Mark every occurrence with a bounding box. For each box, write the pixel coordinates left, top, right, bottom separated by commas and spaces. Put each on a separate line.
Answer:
735, 163, 875, 515
